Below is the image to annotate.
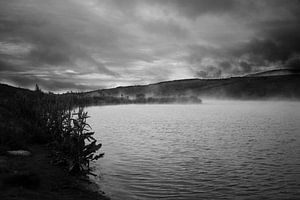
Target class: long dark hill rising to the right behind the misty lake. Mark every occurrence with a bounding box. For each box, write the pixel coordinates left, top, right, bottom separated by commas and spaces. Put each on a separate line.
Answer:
84, 72, 300, 99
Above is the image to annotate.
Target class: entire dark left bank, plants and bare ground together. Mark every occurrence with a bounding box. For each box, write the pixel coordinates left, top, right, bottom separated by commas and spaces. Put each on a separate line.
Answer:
0, 84, 109, 200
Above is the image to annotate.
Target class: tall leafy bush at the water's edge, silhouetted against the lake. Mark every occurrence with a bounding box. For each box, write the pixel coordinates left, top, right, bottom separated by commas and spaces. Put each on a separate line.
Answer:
55, 108, 104, 174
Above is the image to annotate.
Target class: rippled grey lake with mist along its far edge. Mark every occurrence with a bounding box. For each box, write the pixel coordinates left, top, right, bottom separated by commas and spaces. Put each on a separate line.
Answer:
87, 101, 300, 200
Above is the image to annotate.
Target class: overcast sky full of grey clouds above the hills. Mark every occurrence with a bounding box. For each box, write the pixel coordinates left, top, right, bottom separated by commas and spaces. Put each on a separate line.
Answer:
0, 0, 300, 92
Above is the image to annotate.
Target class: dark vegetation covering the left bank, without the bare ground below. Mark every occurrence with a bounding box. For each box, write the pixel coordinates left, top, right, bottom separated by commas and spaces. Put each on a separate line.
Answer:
0, 86, 104, 174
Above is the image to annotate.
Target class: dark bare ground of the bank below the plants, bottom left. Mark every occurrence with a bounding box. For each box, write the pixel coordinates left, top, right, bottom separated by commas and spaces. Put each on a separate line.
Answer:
0, 145, 110, 200
